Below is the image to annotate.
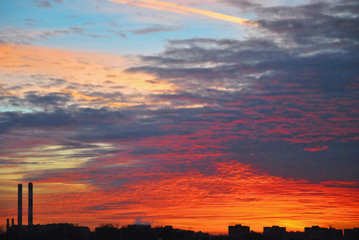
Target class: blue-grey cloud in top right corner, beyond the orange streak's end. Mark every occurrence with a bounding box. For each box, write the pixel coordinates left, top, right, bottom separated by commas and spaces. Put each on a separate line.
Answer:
258, 3, 359, 45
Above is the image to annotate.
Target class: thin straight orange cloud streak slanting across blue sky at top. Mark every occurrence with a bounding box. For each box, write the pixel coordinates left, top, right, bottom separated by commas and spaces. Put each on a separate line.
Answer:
109, 0, 258, 27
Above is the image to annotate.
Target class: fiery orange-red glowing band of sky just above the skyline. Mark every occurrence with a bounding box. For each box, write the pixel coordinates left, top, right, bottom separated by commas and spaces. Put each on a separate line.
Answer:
4, 161, 358, 234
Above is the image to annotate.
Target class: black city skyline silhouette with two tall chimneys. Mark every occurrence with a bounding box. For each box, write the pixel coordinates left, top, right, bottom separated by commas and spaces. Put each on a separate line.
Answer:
0, 182, 359, 240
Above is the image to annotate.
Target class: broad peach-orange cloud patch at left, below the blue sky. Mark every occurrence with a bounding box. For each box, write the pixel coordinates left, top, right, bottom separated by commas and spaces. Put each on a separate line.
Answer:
0, 44, 174, 107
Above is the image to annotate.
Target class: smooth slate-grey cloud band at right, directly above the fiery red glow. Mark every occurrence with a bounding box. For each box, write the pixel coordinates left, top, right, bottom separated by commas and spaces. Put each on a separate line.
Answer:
229, 140, 359, 182
